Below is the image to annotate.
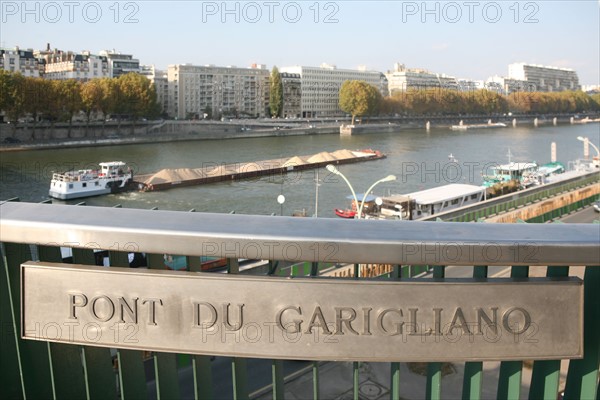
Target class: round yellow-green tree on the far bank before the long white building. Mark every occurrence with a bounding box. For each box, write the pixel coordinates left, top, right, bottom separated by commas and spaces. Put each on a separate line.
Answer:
339, 80, 381, 125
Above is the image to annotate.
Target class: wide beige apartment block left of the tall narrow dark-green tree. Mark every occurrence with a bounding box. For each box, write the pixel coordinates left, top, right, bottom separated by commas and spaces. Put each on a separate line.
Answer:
167, 64, 270, 119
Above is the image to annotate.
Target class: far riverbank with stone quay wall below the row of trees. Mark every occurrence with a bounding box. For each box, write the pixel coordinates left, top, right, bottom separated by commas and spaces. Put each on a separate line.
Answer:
0, 115, 596, 152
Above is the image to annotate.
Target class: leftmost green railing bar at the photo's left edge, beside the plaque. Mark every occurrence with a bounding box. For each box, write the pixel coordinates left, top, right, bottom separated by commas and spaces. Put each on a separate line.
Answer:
0, 244, 25, 399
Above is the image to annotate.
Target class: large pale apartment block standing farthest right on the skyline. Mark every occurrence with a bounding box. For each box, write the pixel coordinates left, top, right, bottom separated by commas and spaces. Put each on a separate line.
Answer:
508, 63, 581, 92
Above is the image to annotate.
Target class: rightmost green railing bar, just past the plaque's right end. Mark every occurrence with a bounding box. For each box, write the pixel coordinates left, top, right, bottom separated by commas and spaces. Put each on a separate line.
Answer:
565, 266, 600, 399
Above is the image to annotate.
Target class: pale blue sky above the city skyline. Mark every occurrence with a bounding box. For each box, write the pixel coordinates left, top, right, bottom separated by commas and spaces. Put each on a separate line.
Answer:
0, 0, 600, 85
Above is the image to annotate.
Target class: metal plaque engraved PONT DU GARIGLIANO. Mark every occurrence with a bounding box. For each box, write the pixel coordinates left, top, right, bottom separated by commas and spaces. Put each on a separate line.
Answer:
21, 262, 583, 361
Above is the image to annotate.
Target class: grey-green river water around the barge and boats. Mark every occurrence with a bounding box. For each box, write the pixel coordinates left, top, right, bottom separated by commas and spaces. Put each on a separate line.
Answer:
0, 124, 600, 217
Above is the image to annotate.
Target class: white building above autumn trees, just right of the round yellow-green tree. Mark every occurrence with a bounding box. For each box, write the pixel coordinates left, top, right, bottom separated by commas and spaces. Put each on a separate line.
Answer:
385, 63, 459, 95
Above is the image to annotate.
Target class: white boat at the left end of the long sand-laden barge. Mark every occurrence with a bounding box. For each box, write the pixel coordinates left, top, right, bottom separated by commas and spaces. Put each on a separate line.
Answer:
48, 161, 133, 200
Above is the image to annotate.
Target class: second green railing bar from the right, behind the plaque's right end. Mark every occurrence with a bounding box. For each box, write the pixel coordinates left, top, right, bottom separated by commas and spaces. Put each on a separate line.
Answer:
529, 267, 569, 400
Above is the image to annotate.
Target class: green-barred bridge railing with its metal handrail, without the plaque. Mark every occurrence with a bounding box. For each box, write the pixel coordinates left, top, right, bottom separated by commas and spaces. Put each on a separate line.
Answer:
0, 202, 600, 400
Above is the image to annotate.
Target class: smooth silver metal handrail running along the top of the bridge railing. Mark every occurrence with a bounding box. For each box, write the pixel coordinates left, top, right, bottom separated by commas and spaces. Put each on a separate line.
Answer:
0, 202, 600, 266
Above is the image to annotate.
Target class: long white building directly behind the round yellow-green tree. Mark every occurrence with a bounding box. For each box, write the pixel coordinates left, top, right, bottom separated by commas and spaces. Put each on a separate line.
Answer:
280, 64, 388, 118
